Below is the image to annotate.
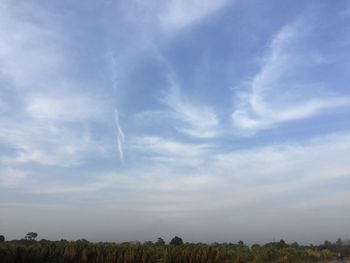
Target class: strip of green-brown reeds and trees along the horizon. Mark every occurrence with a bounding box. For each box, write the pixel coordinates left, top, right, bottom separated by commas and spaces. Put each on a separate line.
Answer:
0, 237, 350, 263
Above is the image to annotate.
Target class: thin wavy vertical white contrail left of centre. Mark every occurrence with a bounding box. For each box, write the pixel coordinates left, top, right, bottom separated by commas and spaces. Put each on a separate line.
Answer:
109, 52, 125, 161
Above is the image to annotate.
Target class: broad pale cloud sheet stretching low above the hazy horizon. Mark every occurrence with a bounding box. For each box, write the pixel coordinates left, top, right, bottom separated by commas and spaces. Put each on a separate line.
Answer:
5, 133, 350, 244
